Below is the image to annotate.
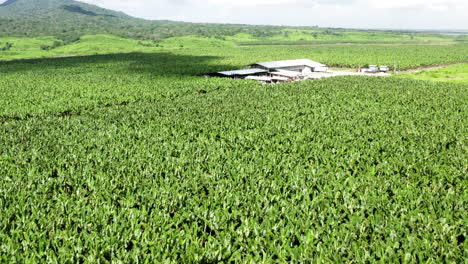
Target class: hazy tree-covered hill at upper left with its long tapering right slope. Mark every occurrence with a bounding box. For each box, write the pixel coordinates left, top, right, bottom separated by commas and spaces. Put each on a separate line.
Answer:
0, 0, 288, 42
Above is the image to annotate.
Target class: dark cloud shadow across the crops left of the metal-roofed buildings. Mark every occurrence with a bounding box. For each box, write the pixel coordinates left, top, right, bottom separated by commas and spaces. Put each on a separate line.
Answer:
0, 52, 233, 76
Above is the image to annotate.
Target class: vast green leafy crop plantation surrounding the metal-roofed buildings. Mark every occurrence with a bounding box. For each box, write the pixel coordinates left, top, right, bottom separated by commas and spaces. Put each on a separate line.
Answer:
0, 46, 468, 263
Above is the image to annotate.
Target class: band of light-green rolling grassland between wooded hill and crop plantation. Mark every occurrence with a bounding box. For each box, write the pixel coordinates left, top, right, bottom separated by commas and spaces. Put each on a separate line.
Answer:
0, 31, 468, 61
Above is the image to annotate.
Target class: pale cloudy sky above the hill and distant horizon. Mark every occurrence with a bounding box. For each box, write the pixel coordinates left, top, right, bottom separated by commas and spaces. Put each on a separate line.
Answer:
82, 0, 468, 30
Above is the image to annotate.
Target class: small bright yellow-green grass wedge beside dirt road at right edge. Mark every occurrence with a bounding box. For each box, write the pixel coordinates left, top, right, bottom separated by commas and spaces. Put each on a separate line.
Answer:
397, 63, 468, 84
